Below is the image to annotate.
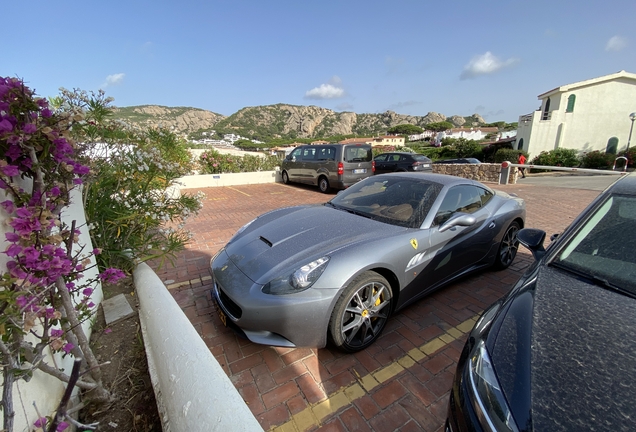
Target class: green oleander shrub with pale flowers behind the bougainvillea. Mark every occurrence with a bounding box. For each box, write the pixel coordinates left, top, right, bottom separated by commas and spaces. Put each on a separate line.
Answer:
58, 89, 201, 271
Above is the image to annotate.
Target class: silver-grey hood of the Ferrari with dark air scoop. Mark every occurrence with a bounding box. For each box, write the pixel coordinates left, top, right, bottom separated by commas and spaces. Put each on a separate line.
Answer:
226, 206, 406, 284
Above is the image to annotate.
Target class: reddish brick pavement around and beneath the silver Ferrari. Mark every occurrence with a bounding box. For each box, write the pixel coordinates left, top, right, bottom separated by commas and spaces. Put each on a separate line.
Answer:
152, 184, 599, 432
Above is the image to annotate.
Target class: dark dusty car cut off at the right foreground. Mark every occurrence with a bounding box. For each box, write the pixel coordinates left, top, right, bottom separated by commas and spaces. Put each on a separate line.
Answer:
446, 174, 636, 432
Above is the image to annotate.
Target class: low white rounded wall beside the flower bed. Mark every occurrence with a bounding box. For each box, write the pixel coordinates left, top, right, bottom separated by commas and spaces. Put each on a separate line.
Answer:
133, 263, 263, 432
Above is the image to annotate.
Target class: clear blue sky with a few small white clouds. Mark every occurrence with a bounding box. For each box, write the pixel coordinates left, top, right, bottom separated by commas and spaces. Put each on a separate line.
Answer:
0, 0, 636, 122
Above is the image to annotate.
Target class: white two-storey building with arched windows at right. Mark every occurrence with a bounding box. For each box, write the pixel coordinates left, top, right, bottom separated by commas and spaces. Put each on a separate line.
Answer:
517, 71, 636, 157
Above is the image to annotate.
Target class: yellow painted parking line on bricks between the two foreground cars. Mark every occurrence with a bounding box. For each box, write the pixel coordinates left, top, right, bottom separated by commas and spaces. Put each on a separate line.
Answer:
269, 314, 479, 432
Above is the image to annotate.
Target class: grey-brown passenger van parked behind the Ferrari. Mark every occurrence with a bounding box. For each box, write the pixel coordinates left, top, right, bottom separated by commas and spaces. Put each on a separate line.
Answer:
281, 143, 375, 193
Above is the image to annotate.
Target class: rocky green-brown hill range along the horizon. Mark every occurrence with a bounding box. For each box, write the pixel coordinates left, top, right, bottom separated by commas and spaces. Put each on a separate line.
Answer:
115, 104, 485, 141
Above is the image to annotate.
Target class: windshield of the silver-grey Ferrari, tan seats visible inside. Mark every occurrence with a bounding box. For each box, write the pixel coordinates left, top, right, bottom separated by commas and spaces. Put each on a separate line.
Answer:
328, 176, 442, 228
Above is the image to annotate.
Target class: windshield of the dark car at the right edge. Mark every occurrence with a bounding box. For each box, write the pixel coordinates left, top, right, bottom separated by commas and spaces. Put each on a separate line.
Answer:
553, 195, 636, 294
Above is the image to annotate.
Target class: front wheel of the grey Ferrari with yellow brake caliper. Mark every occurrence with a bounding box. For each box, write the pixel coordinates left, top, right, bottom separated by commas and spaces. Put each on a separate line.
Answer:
329, 271, 393, 352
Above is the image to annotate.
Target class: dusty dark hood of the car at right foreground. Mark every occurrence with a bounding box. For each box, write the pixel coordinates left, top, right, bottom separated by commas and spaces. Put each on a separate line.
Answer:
531, 267, 636, 431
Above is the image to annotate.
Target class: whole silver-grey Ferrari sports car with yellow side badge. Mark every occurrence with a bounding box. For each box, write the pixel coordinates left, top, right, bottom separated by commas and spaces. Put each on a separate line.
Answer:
210, 173, 526, 352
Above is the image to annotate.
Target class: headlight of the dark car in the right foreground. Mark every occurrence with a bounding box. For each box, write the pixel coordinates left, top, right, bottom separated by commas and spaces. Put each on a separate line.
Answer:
468, 341, 519, 432
